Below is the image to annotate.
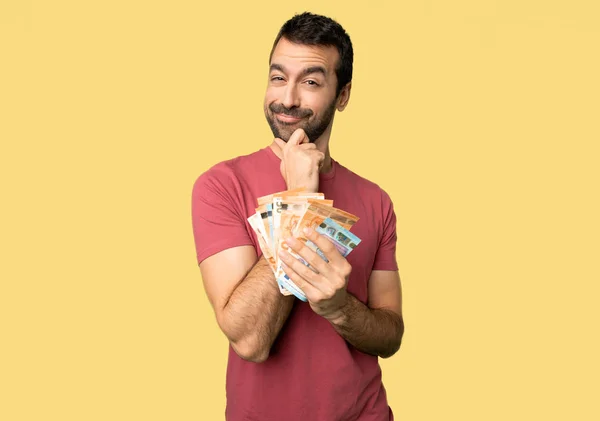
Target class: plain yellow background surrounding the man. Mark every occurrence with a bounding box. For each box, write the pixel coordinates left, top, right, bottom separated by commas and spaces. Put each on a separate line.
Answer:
0, 0, 600, 421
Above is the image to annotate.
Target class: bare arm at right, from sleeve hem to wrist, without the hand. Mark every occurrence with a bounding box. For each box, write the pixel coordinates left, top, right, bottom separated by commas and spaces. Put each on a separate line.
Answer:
329, 270, 404, 358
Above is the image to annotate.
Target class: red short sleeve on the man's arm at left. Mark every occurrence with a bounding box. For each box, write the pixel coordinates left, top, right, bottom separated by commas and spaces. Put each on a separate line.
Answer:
192, 170, 253, 264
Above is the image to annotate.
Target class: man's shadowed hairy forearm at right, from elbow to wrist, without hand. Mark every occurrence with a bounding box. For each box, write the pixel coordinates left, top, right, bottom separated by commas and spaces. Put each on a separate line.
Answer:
329, 293, 404, 358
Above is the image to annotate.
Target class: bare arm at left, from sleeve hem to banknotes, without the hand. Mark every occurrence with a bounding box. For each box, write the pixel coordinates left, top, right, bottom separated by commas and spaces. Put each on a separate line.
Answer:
200, 246, 294, 362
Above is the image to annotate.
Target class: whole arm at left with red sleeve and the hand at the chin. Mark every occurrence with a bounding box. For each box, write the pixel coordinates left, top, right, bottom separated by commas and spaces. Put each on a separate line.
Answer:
192, 129, 324, 362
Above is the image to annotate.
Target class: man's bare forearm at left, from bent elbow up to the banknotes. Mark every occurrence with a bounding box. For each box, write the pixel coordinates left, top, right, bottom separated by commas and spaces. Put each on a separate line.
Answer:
223, 258, 294, 362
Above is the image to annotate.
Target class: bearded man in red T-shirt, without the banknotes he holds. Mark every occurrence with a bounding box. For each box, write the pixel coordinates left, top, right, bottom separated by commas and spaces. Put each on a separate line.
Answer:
192, 13, 404, 421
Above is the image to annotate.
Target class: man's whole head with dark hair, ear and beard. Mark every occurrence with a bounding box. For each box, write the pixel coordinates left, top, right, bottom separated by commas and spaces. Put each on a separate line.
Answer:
264, 12, 354, 142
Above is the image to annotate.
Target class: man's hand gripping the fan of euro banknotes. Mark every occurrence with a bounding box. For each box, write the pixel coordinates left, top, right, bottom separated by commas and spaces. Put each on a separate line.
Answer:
279, 228, 352, 319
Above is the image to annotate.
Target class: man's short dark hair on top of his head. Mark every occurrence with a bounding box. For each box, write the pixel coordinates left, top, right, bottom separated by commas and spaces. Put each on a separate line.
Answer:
269, 12, 354, 97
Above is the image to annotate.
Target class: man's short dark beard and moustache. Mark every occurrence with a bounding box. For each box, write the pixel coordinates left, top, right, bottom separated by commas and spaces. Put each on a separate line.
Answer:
265, 98, 337, 143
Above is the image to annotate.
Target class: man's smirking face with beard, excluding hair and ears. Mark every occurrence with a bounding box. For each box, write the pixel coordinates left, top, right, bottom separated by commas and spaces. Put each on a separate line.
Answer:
264, 38, 339, 142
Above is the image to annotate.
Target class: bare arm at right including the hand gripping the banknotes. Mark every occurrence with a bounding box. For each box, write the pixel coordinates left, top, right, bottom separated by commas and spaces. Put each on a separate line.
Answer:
280, 229, 404, 358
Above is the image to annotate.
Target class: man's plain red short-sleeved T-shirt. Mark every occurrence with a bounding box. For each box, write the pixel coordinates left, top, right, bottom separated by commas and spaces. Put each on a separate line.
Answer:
192, 147, 398, 421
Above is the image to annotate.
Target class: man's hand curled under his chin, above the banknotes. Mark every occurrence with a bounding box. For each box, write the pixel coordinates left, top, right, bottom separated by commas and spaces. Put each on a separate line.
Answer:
275, 129, 325, 192
